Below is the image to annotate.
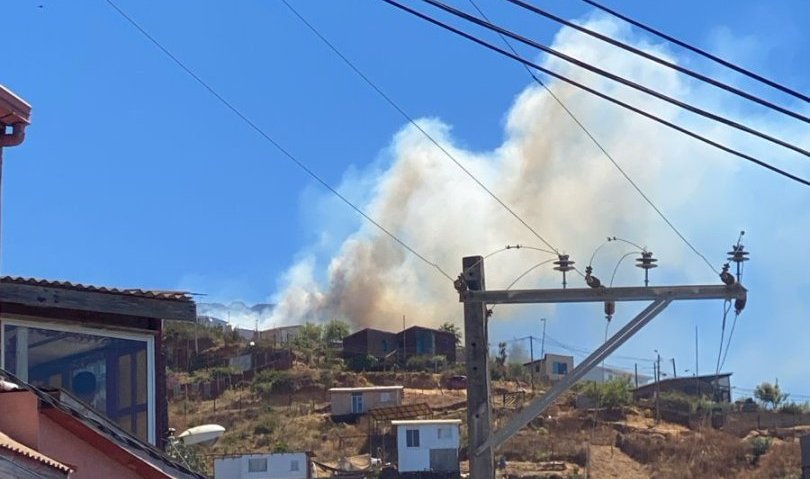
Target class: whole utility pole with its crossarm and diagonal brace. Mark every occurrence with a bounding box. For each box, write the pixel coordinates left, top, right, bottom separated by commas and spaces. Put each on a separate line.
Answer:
455, 256, 747, 479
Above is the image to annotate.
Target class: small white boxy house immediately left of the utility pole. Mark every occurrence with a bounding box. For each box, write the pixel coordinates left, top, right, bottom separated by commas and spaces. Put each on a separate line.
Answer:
391, 419, 461, 478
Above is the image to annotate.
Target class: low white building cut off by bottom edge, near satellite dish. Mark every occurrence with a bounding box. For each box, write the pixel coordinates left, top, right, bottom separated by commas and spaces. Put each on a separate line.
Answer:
214, 452, 312, 479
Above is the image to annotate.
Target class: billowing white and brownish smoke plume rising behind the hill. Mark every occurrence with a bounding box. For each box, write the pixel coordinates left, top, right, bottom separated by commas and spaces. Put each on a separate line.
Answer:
264, 13, 806, 329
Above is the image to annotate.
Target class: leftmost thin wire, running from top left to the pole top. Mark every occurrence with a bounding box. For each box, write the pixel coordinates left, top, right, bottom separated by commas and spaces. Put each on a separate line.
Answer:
107, 0, 453, 281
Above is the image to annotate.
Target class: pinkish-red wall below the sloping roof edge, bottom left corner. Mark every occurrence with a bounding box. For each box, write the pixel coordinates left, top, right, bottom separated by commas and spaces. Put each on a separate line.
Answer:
38, 415, 139, 479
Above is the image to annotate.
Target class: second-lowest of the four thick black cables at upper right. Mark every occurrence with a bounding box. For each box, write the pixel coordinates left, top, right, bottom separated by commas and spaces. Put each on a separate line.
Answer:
422, 0, 810, 157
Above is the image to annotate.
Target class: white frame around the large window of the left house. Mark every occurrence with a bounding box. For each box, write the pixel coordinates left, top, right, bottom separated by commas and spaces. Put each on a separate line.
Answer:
0, 314, 157, 445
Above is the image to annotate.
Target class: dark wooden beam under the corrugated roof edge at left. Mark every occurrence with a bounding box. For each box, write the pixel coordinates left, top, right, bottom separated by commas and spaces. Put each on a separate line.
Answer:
0, 283, 197, 321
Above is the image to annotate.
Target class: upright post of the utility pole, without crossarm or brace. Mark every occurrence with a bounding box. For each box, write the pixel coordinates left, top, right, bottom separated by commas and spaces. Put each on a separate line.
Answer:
462, 256, 495, 479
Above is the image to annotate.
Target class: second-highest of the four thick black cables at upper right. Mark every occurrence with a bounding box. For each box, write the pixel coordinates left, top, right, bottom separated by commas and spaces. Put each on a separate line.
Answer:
507, 0, 810, 123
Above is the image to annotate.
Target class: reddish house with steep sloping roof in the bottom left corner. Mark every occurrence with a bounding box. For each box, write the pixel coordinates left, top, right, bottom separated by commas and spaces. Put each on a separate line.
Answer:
0, 371, 205, 479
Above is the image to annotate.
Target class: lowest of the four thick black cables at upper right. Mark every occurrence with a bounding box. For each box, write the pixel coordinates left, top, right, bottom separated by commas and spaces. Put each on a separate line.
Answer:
382, 0, 810, 186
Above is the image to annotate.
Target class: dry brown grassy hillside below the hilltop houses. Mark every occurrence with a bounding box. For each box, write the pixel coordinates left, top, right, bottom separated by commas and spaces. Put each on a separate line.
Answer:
170, 364, 802, 479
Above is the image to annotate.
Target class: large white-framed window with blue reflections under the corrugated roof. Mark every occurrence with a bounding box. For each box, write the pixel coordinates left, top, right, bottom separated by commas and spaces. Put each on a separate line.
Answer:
2, 317, 155, 443
